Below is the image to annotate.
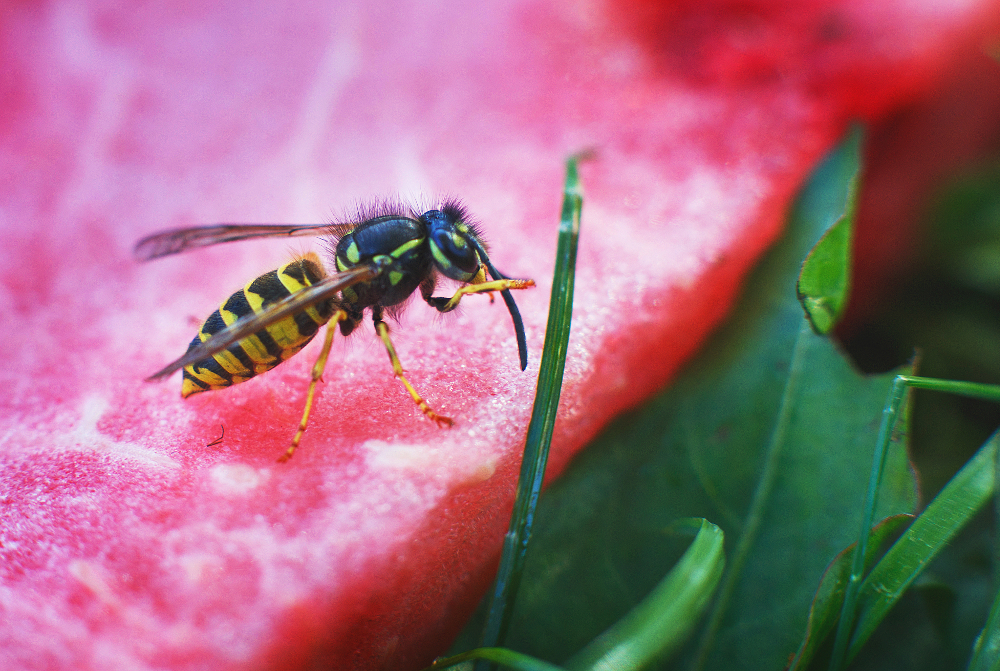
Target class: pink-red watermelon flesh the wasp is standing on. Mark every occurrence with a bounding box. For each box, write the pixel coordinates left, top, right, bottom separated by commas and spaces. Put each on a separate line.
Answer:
0, 0, 1000, 670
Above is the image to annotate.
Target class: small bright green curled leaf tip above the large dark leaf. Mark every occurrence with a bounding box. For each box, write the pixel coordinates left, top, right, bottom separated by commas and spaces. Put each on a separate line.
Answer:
796, 129, 862, 335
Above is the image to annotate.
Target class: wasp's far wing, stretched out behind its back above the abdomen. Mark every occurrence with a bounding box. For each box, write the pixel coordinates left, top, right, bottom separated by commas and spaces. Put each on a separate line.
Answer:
133, 224, 342, 261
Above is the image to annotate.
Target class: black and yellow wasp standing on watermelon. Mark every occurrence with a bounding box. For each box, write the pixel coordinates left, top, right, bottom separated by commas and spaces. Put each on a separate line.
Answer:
135, 201, 535, 462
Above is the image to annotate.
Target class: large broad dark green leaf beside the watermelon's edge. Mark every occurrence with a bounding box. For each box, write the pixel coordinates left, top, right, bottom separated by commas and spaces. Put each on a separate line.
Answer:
450, 131, 915, 669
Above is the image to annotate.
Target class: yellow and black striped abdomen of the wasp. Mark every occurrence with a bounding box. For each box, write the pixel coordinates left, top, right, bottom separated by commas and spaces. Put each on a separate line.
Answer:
181, 253, 335, 398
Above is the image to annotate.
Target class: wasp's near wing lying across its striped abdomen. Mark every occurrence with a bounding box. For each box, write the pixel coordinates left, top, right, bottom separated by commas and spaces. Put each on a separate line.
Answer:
146, 261, 391, 382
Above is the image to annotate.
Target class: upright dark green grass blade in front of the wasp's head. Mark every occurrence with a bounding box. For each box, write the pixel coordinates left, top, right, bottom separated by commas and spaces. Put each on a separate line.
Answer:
476, 156, 583, 669
